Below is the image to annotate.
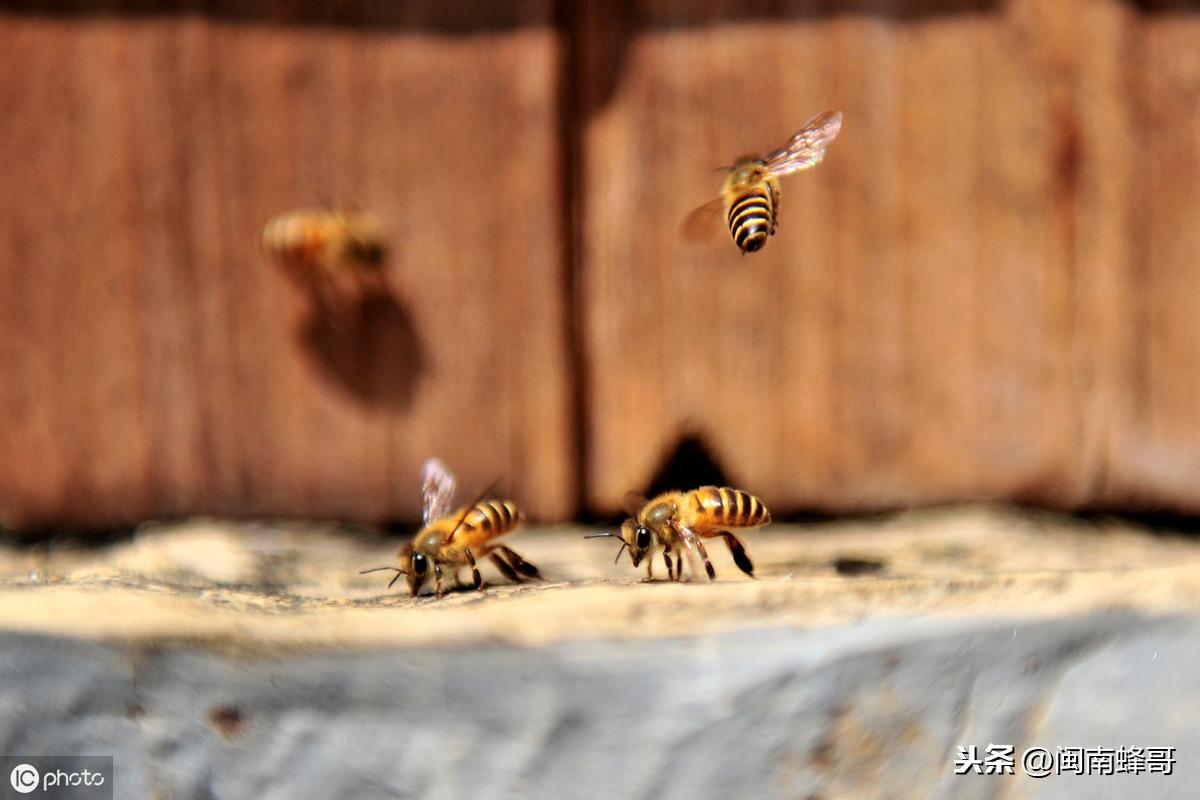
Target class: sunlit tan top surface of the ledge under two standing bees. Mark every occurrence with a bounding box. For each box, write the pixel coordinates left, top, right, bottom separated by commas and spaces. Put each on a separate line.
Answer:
0, 509, 1200, 649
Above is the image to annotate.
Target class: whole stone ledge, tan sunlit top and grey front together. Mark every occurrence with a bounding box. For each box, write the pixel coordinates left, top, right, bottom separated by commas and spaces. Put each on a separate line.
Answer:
0, 510, 1200, 798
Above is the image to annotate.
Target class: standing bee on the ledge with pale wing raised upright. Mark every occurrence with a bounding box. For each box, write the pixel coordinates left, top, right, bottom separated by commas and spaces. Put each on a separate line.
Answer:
359, 458, 540, 597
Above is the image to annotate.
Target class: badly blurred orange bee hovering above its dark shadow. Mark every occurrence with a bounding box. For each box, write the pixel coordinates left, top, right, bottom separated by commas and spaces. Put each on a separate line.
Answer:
258, 209, 388, 299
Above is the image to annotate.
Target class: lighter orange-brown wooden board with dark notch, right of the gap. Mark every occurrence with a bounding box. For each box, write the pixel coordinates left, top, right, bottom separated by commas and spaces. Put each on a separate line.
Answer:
577, 0, 1200, 511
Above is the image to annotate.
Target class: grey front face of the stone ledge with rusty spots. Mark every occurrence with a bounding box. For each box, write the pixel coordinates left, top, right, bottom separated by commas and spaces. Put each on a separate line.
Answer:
0, 612, 1200, 798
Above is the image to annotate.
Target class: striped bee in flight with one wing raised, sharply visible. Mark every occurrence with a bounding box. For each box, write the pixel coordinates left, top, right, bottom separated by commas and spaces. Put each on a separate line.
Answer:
684, 112, 841, 255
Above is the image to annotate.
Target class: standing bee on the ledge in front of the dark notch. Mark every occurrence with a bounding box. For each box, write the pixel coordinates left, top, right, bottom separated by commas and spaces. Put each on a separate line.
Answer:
584, 486, 770, 581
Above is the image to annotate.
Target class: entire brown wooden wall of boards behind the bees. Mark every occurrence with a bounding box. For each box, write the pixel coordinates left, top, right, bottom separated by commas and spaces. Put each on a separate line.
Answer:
0, 0, 1200, 530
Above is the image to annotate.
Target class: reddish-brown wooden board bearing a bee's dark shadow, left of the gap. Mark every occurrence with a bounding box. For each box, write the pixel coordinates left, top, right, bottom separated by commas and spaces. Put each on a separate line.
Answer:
0, 6, 574, 527
